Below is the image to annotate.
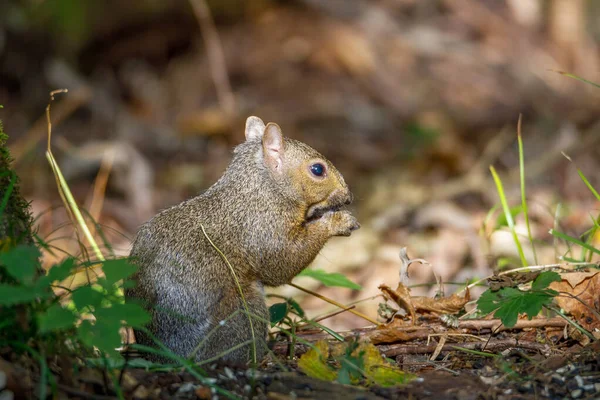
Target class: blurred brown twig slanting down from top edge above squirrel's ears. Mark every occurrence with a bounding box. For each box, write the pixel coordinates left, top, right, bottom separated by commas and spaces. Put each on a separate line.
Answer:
190, 0, 235, 117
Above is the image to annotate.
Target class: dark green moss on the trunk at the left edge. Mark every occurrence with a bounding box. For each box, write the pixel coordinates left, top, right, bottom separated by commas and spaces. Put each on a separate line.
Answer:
0, 117, 33, 247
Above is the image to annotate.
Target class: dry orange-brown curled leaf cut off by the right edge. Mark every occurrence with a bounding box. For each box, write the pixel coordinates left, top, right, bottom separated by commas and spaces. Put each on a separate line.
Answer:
549, 270, 600, 332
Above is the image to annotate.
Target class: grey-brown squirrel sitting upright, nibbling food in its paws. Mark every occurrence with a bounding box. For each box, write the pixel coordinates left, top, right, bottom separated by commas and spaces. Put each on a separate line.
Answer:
125, 116, 360, 364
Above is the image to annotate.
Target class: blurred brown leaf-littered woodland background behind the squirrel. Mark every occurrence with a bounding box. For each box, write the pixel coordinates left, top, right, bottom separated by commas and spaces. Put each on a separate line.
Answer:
0, 0, 600, 326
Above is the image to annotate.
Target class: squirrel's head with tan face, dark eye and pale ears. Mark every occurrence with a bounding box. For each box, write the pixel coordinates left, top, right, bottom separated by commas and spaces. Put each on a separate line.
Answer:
246, 117, 352, 221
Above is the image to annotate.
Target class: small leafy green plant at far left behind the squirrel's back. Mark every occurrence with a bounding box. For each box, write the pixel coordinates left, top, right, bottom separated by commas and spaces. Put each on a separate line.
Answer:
0, 245, 149, 357
